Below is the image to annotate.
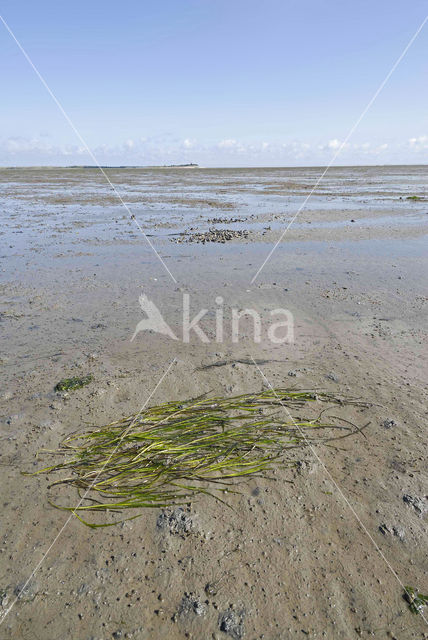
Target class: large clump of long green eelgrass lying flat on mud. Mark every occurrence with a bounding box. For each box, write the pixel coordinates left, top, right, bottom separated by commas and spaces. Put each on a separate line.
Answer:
32, 389, 368, 527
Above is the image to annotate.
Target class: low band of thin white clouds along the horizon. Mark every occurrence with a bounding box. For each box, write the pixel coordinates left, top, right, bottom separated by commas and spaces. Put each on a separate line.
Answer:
0, 133, 428, 166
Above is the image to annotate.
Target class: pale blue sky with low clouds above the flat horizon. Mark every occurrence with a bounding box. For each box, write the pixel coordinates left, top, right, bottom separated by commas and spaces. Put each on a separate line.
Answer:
0, 0, 428, 166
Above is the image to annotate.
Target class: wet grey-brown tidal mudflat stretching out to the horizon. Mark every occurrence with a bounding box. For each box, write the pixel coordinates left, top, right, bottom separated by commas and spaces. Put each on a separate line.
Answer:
0, 166, 428, 640
